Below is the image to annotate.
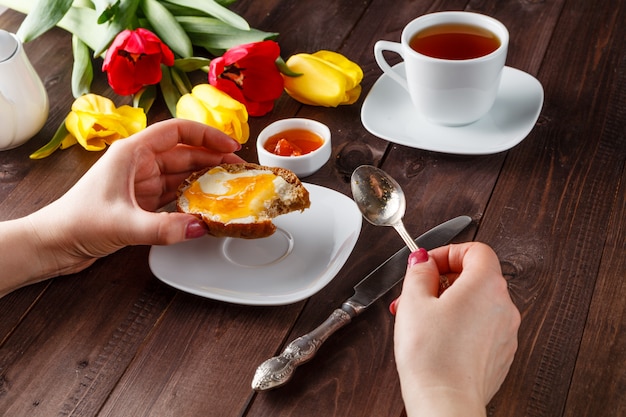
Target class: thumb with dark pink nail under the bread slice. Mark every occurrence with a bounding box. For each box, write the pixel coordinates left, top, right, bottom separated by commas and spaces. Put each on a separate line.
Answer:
130, 212, 207, 245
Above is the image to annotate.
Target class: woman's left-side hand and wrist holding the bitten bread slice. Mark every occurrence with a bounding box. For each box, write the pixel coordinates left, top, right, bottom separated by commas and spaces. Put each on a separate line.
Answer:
0, 119, 243, 295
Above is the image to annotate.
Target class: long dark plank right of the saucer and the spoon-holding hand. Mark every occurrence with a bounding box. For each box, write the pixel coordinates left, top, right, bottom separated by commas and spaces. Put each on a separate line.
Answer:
478, 2, 626, 416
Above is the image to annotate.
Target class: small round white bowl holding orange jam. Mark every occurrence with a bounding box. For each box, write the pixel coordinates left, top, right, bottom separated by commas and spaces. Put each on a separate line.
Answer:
256, 118, 332, 177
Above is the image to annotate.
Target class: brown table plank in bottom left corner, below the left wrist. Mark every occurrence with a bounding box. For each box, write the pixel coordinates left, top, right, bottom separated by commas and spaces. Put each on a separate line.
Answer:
0, 248, 175, 417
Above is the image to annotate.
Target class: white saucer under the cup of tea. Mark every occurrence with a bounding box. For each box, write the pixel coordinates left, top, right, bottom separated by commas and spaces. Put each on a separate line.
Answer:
361, 63, 543, 155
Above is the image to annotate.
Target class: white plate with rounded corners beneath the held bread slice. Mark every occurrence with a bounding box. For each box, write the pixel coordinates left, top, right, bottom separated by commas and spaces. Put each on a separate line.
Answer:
148, 184, 362, 305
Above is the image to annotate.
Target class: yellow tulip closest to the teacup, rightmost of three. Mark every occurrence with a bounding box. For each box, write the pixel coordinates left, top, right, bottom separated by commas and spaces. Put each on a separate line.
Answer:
283, 51, 363, 107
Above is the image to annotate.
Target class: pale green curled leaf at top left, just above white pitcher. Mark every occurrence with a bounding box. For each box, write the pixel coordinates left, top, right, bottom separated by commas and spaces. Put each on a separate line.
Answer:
17, 0, 73, 42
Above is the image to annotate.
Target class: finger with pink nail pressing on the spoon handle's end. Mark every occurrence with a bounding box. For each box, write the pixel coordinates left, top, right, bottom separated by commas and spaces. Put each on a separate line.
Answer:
389, 248, 439, 314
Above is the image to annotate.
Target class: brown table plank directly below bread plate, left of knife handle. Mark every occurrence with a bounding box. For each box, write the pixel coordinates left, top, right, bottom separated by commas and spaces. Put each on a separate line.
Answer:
96, 293, 302, 417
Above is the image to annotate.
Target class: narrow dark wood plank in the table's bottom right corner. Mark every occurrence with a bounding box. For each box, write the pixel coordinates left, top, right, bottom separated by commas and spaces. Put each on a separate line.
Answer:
564, 83, 626, 417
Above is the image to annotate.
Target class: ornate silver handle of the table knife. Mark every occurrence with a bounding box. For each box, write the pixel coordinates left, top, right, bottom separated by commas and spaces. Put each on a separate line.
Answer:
252, 308, 356, 391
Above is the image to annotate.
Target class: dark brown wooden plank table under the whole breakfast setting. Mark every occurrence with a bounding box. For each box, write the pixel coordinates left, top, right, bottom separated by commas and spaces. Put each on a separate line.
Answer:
0, 0, 626, 417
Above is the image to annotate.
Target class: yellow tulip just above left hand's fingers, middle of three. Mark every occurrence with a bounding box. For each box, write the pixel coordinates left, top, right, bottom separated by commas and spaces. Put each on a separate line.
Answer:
176, 84, 250, 143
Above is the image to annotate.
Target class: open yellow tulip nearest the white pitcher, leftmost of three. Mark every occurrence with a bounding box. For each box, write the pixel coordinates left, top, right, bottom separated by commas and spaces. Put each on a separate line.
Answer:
61, 94, 147, 151
